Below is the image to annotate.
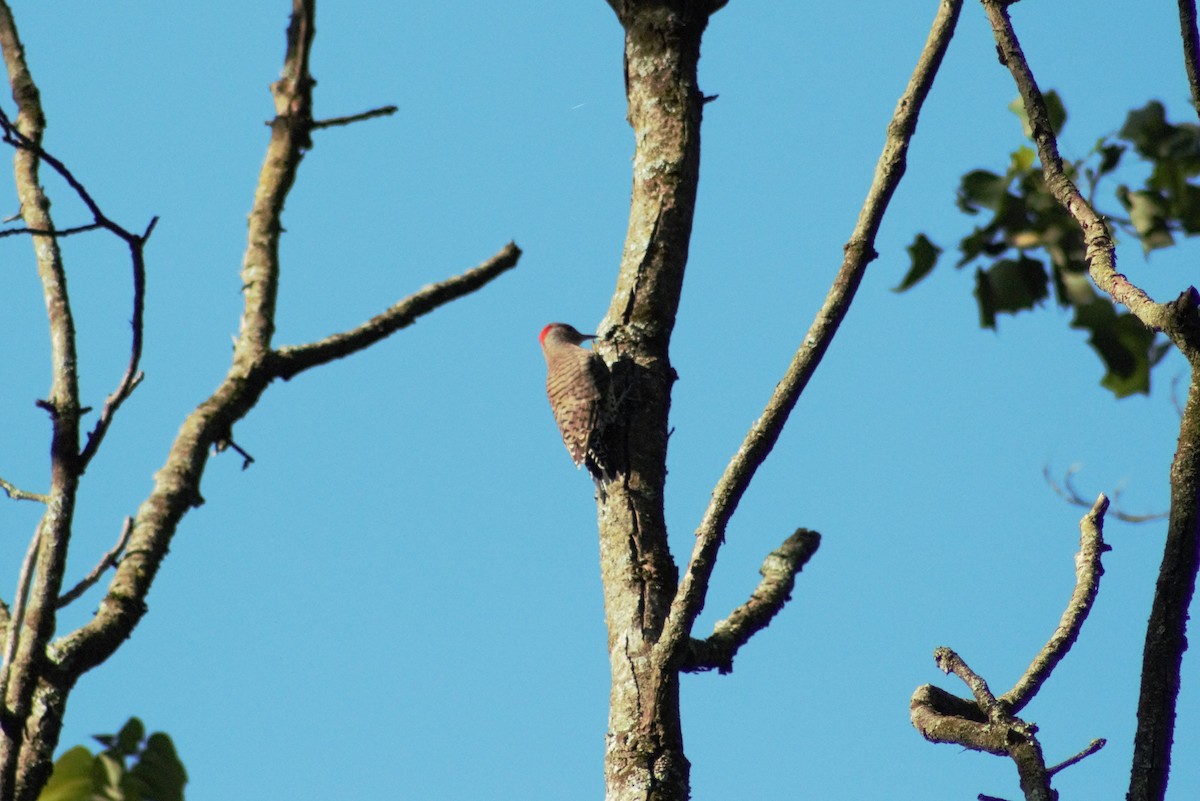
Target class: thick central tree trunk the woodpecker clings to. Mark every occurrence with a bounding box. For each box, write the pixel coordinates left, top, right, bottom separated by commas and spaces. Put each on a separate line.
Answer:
600, 0, 710, 801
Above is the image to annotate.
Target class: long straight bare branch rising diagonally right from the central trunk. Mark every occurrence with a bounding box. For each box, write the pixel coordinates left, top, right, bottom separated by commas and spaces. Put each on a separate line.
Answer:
660, 0, 962, 655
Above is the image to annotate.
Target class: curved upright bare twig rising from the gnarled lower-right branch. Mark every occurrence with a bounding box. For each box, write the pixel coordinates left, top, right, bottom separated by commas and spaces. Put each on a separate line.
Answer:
1001, 494, 1109, 715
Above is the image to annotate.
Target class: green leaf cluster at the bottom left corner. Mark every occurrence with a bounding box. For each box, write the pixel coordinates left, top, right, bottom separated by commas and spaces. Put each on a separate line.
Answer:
37, 717, 187, 801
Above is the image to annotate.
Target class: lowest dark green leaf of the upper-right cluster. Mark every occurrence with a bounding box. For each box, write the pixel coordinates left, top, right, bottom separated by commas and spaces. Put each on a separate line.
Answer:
1070, 295, 1163, 398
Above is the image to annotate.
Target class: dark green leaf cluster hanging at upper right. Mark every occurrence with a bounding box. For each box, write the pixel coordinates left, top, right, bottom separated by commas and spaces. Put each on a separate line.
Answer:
896, 91, 1200, 397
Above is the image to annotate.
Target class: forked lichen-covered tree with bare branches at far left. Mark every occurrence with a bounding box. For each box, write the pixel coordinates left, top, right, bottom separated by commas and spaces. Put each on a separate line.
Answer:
0, 0, 520, 801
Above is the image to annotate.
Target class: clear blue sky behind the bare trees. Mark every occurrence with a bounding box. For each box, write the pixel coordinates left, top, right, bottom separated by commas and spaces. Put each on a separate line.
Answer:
0, 0, 1200, 801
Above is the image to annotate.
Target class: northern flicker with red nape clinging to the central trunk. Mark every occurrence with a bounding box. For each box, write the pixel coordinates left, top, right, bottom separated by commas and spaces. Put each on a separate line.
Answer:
538, 323, 614, 489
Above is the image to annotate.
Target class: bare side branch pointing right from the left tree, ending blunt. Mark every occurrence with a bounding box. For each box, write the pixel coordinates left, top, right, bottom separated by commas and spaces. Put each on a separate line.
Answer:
270, 242, 521, 380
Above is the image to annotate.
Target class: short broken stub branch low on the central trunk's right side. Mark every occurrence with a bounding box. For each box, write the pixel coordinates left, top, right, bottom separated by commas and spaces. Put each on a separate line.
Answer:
680, 529, 821, 673
